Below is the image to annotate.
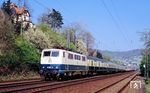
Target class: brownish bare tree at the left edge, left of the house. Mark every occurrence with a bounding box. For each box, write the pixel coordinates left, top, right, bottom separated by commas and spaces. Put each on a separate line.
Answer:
0, 10, 14, 54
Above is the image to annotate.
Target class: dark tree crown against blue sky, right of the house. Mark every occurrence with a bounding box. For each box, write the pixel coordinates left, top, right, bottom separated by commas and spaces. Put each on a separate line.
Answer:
39, 9, 64, 29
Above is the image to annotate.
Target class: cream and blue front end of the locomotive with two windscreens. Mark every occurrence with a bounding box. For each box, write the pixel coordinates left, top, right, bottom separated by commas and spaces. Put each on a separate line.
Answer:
40, 49, 61, 80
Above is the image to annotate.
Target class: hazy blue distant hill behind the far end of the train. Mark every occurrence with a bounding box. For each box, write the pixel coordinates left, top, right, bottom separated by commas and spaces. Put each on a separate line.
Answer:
100, 49, 142, 64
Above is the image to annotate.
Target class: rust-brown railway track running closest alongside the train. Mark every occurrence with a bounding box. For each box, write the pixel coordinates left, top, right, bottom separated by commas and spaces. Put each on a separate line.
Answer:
0, 72, 132, 93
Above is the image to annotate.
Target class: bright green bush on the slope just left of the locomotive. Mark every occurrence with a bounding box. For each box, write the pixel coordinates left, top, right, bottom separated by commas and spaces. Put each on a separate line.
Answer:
15, 37, 40, 63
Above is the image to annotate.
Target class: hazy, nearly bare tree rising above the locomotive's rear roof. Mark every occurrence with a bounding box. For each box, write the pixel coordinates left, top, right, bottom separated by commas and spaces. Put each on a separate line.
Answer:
63, 23, 94, 54
